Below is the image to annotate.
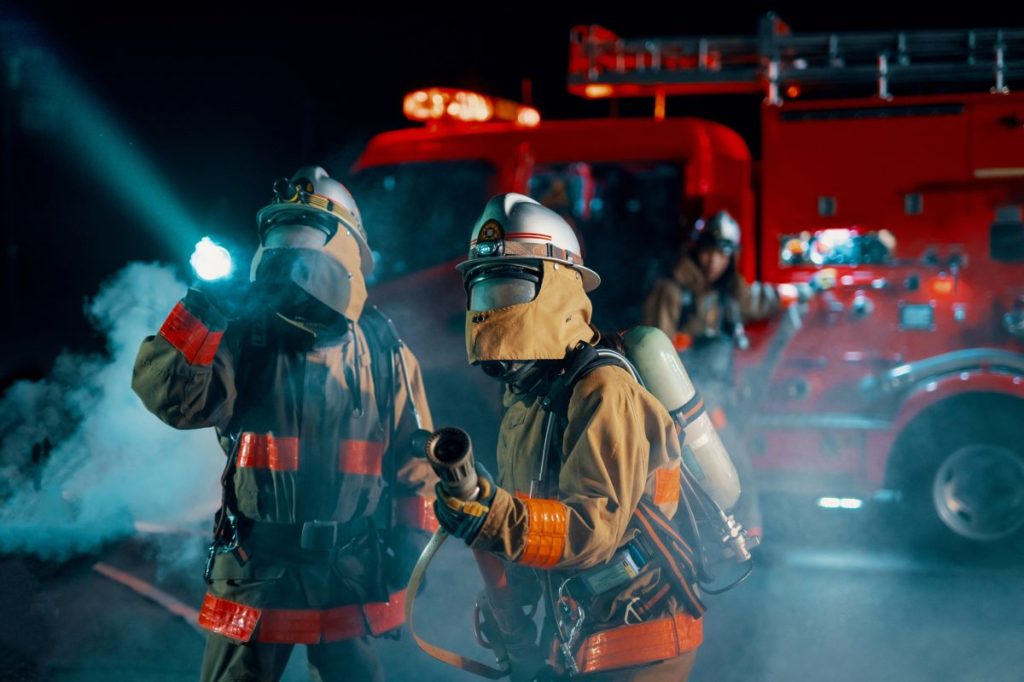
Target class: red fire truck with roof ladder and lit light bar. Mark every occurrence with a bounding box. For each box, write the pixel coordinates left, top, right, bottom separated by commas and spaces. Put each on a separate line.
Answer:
351, 15, 1024, 544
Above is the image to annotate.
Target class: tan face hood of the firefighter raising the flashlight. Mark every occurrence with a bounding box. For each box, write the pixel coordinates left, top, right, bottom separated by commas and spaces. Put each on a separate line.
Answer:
250, 222, 367, 322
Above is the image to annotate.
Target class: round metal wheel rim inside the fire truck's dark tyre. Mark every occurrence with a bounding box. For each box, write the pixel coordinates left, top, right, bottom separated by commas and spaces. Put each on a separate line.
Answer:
932, 443, 1024, 542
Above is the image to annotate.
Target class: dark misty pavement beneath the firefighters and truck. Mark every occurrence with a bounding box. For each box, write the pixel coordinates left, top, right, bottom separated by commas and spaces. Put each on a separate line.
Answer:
0, 499, 1024, 682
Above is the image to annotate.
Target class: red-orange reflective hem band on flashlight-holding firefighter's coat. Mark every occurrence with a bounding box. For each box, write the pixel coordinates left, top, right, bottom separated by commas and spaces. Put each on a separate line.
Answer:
199, 590, 406, 644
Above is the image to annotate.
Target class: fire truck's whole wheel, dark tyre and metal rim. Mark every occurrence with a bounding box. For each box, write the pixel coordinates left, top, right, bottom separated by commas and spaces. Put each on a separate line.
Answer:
900, 396, 1024, 548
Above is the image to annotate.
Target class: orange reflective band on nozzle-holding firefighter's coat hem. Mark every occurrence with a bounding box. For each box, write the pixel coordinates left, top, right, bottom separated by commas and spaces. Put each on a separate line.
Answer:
577, 613, 703, 673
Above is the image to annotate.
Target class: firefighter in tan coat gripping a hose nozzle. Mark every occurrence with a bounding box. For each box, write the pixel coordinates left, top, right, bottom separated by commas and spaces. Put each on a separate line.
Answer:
435, 194, 703, 681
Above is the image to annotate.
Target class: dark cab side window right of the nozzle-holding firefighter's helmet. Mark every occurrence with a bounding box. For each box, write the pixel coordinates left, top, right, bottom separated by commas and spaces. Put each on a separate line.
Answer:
529, 162, 695, 329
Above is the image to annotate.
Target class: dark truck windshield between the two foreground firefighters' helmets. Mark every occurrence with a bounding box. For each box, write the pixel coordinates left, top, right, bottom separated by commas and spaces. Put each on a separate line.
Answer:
348, 161, 495, 284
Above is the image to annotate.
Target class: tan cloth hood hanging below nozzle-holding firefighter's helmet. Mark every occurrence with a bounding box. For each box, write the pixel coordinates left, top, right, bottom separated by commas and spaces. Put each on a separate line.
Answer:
466, 261, 599, 365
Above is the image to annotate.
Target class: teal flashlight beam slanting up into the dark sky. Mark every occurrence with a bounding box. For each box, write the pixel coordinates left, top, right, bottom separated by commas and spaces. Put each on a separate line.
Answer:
27, 35, 202, 252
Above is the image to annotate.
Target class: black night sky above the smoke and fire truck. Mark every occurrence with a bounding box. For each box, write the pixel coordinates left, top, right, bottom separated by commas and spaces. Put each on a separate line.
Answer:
0, 0, 1024, 387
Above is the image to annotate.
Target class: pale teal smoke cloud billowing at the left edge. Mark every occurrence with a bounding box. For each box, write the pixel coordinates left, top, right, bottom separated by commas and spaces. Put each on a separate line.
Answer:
0, 263, 224, 559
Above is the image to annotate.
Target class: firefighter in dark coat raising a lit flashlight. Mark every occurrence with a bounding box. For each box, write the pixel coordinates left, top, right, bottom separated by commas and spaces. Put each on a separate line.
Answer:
132, 167, 436, 682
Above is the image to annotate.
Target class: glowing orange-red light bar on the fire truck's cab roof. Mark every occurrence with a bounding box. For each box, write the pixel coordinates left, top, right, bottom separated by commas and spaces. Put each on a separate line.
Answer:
401, 88, 541, 128
